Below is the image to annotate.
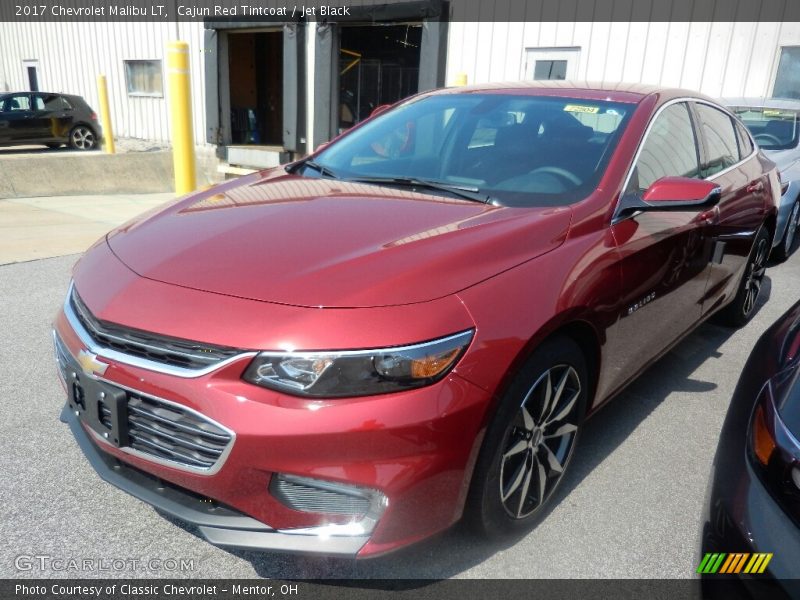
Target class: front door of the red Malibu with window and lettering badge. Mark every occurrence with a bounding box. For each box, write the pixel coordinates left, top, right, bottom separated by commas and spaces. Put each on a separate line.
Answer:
611, 101, 713, 387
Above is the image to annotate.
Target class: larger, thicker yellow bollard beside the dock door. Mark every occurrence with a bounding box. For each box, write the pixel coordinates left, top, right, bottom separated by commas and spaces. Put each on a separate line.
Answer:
167, 42, 197, 196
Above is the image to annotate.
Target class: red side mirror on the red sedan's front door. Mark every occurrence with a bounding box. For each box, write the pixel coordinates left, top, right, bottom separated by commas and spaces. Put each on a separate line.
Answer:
612, 177, 722, 223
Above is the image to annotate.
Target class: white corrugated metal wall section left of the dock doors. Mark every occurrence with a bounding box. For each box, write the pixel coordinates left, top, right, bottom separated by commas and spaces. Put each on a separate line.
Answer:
0, 22, 205, 145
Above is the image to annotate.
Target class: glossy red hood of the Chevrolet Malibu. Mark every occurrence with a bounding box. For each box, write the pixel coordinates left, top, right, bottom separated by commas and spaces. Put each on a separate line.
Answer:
108, 174, 571, 308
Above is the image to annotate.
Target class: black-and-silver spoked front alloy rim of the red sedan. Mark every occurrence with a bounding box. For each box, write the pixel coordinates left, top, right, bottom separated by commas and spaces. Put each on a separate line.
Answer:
500, 365, 581, 519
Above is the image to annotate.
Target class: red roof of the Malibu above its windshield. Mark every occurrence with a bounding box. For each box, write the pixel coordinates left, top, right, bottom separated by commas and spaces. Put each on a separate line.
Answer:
433, 80, 718, 104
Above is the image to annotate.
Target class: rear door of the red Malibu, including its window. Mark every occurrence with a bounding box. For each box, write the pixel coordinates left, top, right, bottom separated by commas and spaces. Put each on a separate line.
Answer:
692, 101, 771, 313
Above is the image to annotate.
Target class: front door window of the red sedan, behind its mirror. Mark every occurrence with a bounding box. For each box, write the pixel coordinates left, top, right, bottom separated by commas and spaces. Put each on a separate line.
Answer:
625, 102, 699, 193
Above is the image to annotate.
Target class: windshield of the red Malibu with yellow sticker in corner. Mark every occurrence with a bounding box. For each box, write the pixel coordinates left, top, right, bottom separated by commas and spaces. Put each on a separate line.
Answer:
301, 94, 634, 206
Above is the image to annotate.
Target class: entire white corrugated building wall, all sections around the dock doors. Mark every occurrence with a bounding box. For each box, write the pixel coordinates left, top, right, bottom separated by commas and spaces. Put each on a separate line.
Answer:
0, 17, 800, 145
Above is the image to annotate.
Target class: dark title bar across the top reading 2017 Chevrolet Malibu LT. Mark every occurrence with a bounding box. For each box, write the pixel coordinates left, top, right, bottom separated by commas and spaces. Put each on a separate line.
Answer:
0, 0, 800, 22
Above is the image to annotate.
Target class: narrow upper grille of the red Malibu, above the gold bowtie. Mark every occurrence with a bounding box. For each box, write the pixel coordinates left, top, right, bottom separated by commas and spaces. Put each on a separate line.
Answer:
69, 286, 242, 369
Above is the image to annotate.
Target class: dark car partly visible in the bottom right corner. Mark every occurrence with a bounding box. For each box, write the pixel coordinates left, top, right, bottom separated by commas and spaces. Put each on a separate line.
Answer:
698, 302, 800, 599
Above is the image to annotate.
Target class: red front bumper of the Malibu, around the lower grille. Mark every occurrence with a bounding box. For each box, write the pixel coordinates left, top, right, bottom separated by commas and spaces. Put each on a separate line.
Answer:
56, 311, 489, 557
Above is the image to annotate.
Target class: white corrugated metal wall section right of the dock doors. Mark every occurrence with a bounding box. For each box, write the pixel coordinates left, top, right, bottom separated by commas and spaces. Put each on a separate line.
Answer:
447, 22, 800, 96
